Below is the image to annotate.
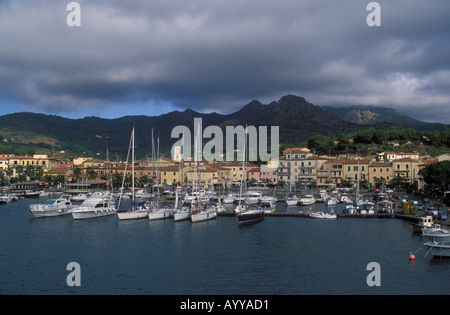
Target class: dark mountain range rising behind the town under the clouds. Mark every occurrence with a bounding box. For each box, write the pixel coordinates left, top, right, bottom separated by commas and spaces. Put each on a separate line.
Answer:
0, 95, 444, 160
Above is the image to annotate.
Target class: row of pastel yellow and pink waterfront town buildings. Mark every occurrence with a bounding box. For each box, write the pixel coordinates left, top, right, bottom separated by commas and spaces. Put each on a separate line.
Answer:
0, 148, 450, 189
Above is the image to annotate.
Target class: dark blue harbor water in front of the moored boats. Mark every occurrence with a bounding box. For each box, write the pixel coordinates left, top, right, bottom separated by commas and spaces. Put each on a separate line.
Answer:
0, 197, 450, 295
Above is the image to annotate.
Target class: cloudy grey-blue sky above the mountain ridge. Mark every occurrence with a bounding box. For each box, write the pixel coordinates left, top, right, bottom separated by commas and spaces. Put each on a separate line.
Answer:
0, 0, 450, 124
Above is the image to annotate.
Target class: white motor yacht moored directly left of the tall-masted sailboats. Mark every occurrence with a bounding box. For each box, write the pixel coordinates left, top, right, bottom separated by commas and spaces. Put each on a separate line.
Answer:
72, 197, 117, 220
